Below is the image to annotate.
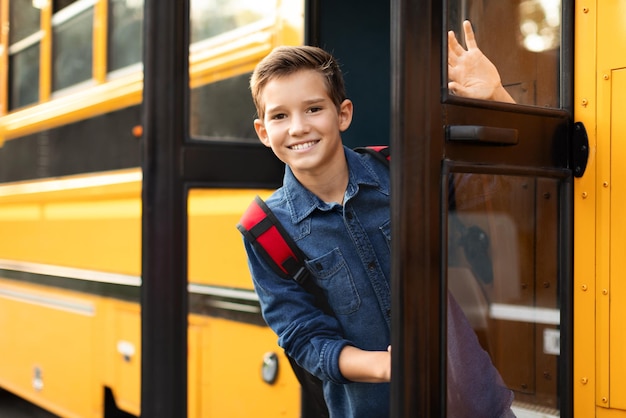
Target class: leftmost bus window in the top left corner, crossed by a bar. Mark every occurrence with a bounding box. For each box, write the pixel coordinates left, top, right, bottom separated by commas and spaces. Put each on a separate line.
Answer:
8, 0, 42, 110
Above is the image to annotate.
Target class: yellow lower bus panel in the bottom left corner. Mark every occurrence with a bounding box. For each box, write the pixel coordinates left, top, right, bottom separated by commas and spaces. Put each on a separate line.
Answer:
0, 279, 100, 417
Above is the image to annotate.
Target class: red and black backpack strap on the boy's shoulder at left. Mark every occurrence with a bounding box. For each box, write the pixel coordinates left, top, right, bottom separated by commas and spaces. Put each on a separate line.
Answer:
237, 196, 308, 284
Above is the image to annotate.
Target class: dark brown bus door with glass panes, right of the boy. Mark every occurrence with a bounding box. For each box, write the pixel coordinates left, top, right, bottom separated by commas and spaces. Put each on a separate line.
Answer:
392, 0, 576, 417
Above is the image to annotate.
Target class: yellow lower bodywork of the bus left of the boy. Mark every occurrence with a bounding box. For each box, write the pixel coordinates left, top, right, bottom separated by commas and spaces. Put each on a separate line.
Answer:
0, 170, 299, 417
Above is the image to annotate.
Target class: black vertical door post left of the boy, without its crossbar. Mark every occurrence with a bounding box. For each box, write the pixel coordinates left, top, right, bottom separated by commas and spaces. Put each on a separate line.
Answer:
141, 0, 189, 418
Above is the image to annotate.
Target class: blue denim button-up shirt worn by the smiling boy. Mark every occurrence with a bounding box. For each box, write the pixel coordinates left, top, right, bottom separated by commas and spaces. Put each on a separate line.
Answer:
245, 147, 391, 418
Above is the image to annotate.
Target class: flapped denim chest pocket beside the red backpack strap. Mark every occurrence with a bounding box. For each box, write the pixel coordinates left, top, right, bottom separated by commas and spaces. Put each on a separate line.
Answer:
307, 248, 361, 315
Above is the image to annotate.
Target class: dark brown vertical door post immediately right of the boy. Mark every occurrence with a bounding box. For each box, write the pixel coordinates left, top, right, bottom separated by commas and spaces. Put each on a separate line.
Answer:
391, 0, 445, 417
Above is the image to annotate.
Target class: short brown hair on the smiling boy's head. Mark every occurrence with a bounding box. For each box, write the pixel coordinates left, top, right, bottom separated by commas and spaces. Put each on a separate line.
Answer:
250, 45, 346, 118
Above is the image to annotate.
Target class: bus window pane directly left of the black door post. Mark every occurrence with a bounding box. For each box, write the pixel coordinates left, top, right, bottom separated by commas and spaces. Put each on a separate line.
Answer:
108, 0, 143, 72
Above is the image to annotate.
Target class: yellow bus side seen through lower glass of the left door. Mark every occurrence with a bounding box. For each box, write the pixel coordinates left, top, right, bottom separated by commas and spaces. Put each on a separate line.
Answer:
188, 189, 300, 418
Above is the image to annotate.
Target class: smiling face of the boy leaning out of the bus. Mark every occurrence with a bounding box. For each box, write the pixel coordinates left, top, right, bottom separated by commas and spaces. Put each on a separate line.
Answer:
254, 70, 352, 177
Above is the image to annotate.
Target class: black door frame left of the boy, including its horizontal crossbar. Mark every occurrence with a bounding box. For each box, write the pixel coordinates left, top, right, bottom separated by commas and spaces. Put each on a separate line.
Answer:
141, 0, 284, 418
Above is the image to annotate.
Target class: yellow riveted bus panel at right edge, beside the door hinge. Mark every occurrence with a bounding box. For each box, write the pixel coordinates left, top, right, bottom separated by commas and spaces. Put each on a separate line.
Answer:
573, 1, 626, 418
